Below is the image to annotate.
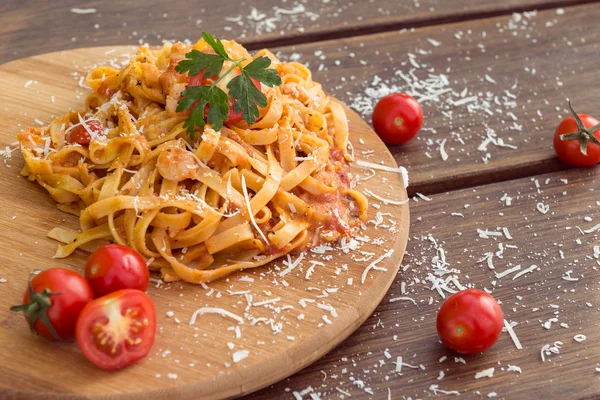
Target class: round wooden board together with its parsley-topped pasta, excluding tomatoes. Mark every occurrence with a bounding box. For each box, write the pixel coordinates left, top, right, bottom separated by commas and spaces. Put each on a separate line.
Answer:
0, 35, 409, 399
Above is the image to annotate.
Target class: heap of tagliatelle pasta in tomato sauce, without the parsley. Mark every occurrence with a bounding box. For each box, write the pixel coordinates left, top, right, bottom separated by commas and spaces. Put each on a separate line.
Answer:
18, 36, 368, 283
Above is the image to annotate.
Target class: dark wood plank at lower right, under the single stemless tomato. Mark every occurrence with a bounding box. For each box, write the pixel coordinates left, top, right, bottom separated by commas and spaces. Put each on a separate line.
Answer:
250, 168, 600, 400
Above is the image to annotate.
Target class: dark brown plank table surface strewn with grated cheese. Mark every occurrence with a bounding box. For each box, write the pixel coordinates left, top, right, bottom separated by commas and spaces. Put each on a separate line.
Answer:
0, 0, 600, 400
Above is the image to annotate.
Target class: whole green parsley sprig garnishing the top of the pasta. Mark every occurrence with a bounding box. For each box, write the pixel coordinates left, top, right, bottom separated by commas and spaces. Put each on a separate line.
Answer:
175, 32, 281, 139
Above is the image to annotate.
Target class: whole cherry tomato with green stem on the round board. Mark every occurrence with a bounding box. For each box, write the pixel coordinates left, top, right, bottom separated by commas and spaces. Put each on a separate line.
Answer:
11, 268, 94, 340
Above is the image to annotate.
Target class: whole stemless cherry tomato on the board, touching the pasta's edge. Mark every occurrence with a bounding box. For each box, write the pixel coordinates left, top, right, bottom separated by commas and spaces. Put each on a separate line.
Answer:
85, 244, 150, 297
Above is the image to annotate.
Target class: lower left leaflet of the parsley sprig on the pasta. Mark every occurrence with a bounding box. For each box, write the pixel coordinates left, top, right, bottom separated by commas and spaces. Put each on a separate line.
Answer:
176, 85, 229, 140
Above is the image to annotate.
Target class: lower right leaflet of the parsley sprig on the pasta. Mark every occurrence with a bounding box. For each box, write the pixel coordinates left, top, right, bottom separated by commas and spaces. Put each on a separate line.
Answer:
227, 69, 268, 124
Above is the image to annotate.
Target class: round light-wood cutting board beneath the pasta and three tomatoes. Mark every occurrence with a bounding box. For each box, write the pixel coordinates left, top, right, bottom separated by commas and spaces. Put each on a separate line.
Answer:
0, 47, 409, 400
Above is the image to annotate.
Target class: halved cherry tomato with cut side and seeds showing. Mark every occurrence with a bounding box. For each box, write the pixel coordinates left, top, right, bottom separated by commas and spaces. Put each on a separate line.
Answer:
76, 289, 156, 369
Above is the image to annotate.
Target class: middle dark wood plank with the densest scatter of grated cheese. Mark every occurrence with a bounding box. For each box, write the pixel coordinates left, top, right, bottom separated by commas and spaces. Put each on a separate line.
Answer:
270, 5, 600, 193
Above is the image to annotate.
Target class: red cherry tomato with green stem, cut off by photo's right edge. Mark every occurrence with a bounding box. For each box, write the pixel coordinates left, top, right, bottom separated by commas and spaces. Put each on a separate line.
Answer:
554, 104, 600, 167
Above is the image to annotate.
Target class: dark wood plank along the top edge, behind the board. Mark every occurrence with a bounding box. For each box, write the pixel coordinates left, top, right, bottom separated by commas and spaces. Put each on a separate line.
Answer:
0, 0, 594, 63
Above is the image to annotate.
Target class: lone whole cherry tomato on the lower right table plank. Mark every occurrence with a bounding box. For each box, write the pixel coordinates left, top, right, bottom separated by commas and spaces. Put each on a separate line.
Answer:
437, 289, 504, 354
